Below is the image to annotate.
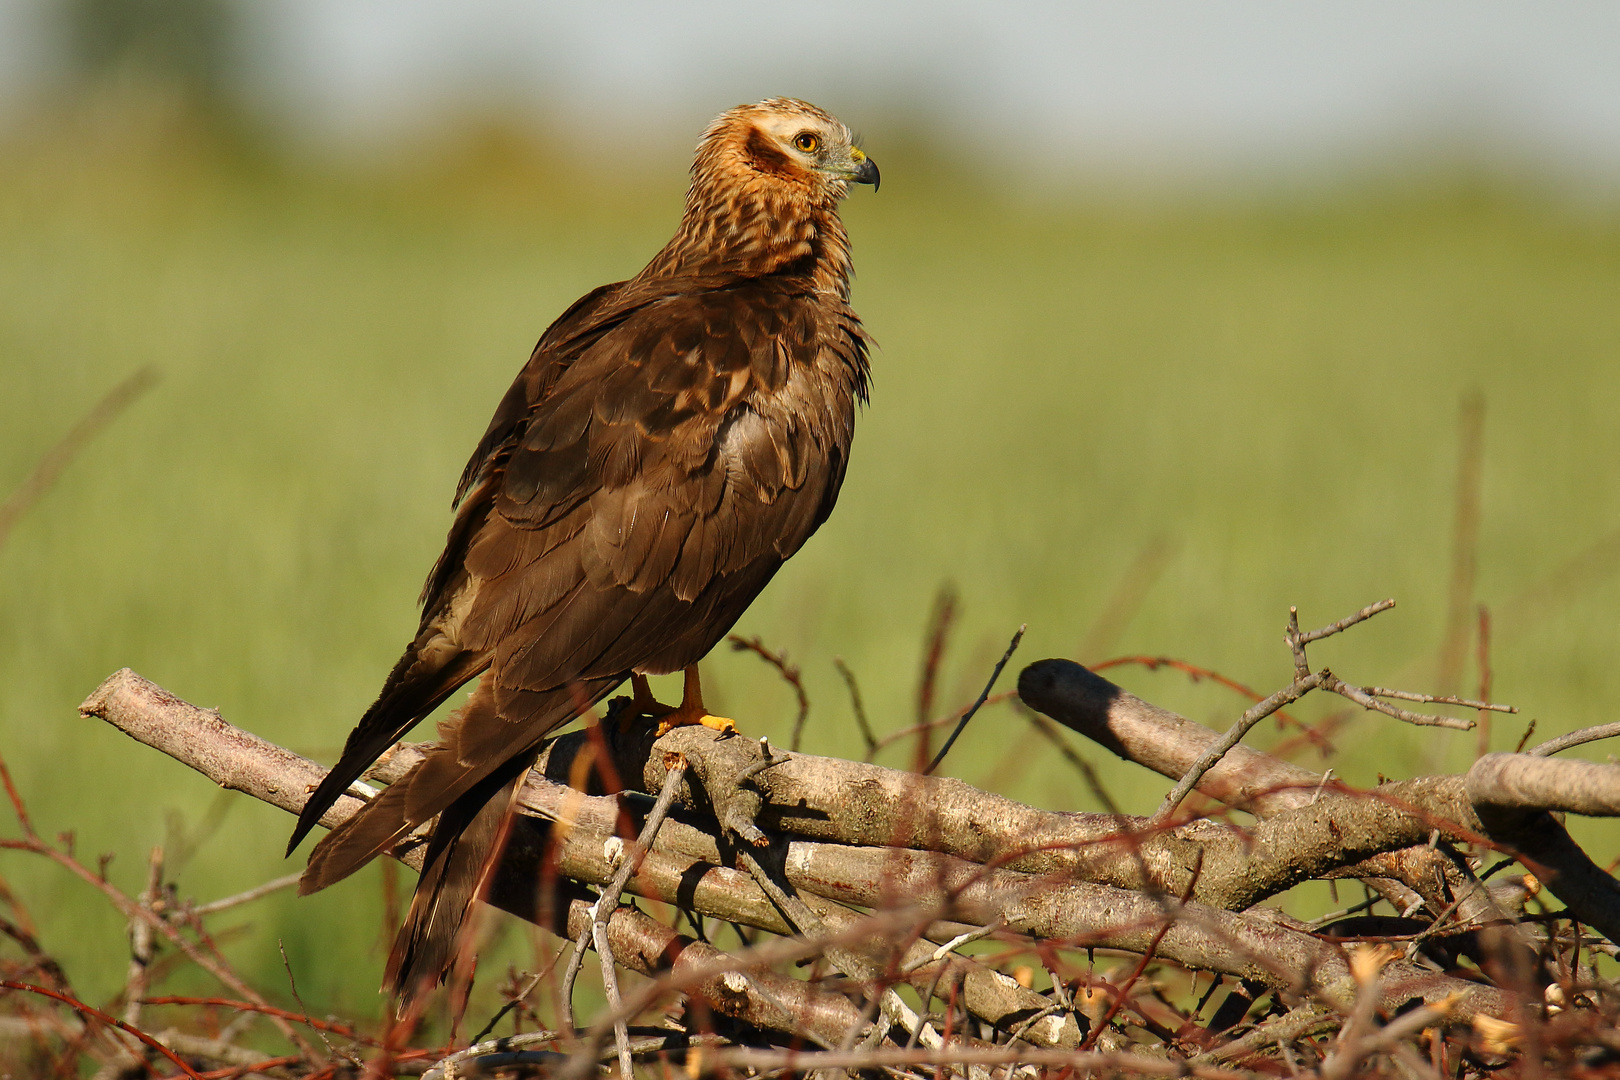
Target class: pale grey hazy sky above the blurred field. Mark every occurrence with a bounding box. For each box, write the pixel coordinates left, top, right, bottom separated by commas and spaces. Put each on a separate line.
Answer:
9, 0, 1620, 181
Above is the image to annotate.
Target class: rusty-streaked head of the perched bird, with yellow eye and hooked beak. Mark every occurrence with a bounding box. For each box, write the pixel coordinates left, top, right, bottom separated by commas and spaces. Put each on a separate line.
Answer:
693, 97, 880, 202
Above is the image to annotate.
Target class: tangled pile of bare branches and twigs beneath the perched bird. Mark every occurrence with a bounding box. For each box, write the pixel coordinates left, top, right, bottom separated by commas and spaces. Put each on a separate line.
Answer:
0, 601, 1620, 1080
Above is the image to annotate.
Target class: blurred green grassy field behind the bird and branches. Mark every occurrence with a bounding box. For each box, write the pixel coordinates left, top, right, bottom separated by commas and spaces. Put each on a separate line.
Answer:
0, 110, 1620, 1029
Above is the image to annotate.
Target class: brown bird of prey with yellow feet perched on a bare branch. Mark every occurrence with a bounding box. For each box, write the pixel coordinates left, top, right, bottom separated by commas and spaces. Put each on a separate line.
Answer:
287, 97, 878, 1010
